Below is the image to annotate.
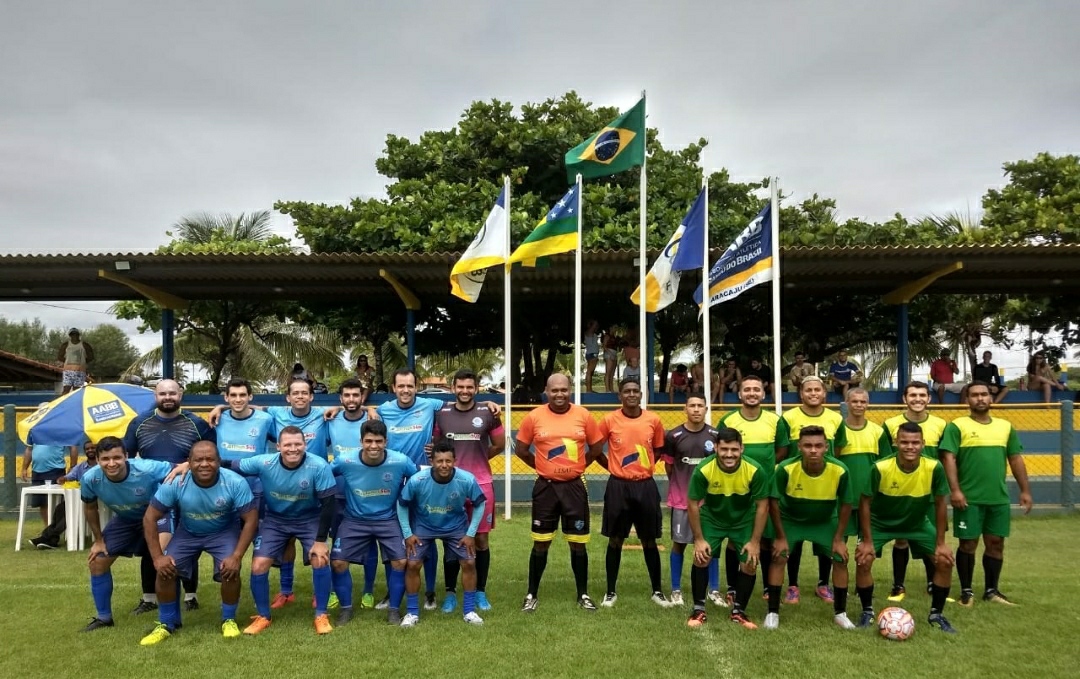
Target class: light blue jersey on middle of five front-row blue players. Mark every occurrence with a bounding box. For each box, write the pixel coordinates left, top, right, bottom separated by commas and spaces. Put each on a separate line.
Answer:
240, 452, 335, 519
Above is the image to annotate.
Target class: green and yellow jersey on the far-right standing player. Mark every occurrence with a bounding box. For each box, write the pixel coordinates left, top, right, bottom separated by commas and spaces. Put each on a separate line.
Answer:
939, 416, 1024, 504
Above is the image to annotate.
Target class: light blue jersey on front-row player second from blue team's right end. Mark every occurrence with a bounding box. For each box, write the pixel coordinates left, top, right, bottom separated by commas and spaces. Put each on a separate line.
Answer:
334, 450, 417, 521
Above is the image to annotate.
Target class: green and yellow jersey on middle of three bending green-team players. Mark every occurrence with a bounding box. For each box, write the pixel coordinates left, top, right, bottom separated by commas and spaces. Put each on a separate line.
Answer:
771, 458, 855, 524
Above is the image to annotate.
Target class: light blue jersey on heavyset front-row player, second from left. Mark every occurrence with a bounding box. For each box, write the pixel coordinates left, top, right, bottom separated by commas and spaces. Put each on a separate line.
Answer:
150, 470, 257, 535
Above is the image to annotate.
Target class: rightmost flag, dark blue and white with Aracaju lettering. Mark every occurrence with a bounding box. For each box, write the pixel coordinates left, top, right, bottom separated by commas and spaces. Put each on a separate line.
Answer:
693, 204, 773, 310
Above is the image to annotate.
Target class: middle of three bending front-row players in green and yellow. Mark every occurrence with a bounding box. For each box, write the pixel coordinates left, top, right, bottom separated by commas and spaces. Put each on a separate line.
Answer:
765, 423, 855, 629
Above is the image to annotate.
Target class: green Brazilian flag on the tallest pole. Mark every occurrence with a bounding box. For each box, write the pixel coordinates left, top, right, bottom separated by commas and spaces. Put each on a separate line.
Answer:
566, 97, 645, 182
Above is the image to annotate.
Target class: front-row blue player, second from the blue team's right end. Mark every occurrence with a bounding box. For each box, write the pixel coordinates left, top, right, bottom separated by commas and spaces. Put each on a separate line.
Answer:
330, 420, 417, 625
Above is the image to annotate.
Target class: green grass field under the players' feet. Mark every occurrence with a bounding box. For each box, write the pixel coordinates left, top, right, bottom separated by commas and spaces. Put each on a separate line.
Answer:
0, 508, 1080, 679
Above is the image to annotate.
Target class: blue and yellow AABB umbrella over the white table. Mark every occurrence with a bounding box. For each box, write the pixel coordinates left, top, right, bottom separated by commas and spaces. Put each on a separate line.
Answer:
18, 384, 154, 446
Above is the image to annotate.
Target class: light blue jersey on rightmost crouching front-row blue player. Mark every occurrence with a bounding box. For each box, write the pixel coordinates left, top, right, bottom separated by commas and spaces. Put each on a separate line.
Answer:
401, 468, 484, 538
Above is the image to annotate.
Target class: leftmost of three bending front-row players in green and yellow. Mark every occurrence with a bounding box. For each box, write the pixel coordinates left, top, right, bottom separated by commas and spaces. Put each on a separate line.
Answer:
686, 426, 771, 629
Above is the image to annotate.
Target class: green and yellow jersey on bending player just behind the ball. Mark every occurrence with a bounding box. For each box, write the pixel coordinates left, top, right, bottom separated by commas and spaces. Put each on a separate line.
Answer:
864, 457, 949, 534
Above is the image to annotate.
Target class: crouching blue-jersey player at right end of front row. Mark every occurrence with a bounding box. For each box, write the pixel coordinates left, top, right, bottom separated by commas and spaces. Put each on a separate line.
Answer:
397, 438, 487, 627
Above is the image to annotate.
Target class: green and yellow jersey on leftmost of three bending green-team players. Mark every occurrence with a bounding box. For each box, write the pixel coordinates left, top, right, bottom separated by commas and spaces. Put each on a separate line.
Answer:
687, 454, 769, 534
